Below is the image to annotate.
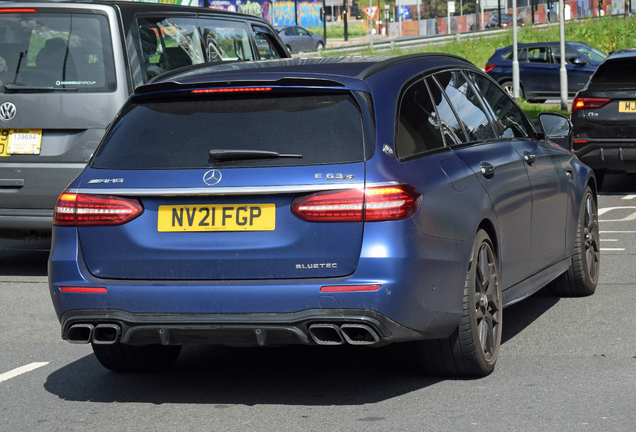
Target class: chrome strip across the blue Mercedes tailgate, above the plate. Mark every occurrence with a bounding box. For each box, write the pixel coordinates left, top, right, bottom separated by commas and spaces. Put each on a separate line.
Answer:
68, 181, 402, 196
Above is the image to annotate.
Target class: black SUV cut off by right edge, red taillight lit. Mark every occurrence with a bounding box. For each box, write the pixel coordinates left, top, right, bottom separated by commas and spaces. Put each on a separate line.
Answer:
570, 48, 636, 187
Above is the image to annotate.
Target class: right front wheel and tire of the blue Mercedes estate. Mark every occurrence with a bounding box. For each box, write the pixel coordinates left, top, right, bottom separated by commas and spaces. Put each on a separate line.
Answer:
548, 186, 601, 297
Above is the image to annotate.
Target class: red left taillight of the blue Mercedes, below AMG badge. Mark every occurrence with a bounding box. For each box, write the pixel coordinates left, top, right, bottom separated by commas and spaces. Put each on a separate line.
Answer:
53, 192, 144, 226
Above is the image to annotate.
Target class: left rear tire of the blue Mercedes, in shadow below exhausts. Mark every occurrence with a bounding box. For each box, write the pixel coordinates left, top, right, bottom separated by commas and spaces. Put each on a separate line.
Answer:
91, 343, 181, 372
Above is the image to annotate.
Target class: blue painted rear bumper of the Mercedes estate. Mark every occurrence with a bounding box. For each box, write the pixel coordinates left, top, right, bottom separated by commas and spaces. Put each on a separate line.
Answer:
48, 223, 472, 344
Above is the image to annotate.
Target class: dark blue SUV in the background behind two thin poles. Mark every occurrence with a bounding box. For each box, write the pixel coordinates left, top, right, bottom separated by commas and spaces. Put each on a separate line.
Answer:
485, 42, 606, 102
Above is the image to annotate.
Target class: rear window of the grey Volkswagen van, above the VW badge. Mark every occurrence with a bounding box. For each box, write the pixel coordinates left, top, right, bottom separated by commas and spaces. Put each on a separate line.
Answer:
0, 13, 117, 92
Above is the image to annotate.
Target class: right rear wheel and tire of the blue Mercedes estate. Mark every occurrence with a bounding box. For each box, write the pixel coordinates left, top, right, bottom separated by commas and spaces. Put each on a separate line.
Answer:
417, 230, 502, 377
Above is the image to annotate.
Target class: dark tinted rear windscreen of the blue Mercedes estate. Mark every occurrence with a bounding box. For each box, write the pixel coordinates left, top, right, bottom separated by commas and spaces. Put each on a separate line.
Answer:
91, 94, 364, 169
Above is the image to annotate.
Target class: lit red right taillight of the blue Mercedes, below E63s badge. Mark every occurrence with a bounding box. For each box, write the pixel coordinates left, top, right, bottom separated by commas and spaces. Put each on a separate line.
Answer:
291, 185, 422, 222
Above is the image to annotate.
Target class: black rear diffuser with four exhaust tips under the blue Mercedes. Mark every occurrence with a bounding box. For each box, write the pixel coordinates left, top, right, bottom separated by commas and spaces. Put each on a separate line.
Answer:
62, 309, 428, 346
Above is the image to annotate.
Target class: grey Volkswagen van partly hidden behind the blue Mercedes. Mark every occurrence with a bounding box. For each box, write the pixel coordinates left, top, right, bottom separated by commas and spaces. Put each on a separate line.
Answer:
0, 1, 289, 238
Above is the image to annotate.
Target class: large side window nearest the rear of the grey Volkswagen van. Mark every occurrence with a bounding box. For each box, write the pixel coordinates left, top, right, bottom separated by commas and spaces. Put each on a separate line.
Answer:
137, 17, 254, 80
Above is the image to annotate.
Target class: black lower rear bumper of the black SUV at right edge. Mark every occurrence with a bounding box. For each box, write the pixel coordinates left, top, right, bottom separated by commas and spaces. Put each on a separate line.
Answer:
574, 138, 636, 171
